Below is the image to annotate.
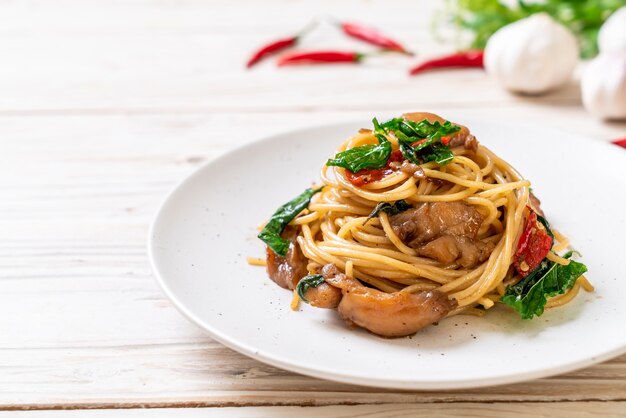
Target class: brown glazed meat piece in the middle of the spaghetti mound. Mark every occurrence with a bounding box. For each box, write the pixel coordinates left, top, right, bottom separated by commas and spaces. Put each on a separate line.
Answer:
389, 202, 494, 268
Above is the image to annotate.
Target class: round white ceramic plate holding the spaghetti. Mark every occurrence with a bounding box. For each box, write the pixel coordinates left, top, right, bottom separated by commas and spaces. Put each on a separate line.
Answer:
149, 120, 626, 389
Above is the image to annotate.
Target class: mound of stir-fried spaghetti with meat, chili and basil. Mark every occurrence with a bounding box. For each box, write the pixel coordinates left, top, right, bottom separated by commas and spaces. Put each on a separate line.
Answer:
250, 113, 593, 336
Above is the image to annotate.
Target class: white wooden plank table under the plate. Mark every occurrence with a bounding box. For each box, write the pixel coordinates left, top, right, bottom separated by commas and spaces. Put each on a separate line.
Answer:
0, 0, 626, 418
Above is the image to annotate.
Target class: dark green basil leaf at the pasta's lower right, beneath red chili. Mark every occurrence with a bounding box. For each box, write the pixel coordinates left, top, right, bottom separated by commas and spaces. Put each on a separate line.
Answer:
500, 251, 587, 319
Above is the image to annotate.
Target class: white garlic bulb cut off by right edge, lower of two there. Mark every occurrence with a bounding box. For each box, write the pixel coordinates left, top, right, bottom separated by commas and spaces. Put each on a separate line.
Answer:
581, 50, 626, 119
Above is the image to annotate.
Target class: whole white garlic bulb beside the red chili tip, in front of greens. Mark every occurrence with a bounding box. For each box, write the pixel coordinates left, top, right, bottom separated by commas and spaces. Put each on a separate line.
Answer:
484, 13, 579, 94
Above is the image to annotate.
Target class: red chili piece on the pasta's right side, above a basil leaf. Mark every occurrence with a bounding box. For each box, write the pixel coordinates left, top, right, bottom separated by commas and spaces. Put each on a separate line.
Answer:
513, 210, 552, 277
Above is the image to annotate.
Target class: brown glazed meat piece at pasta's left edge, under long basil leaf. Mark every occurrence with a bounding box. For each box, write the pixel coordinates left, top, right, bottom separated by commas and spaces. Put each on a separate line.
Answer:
267, 226, 308, 290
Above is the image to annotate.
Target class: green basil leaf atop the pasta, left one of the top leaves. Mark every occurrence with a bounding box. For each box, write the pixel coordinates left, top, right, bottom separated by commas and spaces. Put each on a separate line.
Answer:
326, 139, 391, 173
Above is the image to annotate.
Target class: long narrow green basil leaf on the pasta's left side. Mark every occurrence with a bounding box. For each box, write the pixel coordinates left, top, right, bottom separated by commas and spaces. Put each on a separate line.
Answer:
258, 186, 323, 257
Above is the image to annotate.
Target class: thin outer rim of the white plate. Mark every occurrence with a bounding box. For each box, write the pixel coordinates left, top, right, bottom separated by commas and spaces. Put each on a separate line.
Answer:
147, 117, 626, 391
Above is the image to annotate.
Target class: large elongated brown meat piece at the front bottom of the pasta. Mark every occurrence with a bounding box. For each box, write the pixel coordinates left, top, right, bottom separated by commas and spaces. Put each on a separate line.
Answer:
322, 264, 457, 338
